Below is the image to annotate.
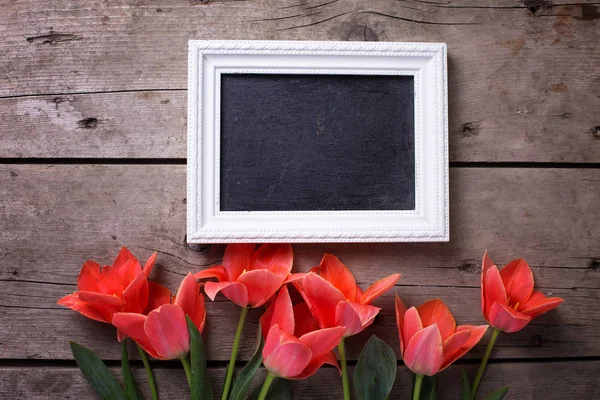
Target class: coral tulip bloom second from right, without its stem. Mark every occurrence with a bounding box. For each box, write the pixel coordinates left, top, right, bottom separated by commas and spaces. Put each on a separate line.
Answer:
396, 296, 488, 376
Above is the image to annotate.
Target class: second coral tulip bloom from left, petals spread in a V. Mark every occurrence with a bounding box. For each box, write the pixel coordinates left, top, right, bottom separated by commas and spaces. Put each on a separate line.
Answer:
113, 274, 206, 360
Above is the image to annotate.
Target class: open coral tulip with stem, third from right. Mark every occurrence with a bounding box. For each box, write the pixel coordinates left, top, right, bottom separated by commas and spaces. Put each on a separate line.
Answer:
293, 254, 400, 400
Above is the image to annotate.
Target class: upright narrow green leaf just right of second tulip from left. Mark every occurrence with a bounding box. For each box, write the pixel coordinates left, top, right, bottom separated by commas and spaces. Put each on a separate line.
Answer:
186, 315, 213, 400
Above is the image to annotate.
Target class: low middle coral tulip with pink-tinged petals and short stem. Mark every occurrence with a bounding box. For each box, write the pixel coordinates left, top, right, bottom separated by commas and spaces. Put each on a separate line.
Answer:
259, 286, 344, 399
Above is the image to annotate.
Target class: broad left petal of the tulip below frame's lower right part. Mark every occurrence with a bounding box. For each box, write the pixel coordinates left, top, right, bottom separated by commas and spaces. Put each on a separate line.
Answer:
301, 273, 346, 328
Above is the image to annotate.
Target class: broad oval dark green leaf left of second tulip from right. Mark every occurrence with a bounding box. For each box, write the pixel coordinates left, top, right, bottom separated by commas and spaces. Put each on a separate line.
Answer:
354, 335, 398, 400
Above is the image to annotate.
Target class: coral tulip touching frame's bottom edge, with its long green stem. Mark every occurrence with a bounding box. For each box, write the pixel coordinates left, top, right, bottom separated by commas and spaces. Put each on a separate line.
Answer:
194, 244, 293, 400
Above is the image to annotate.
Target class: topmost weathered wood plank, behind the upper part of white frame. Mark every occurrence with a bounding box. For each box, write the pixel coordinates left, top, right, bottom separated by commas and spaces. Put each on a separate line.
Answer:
0, 0, 600, 162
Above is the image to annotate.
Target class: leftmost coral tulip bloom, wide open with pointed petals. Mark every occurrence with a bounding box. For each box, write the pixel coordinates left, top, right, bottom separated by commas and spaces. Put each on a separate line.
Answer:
58, 247, 160, 323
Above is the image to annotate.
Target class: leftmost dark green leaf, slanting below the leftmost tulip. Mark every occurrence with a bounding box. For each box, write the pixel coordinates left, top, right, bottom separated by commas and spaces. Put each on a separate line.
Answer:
69, 342, 128, 400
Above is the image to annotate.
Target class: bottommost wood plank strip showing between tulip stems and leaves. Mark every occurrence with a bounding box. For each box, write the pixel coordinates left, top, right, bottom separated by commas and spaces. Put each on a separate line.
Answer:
0, 361, 600, 400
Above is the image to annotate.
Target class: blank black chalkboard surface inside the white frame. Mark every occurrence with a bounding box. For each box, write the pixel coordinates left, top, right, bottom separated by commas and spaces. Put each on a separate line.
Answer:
220, 74, 415, 211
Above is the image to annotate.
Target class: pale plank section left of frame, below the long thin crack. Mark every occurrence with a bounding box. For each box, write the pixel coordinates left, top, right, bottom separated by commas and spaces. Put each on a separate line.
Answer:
0, 91, 187, 158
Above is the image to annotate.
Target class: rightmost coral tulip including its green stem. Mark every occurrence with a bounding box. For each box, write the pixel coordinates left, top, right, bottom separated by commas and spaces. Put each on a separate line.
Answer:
471, 251, 564, 398
